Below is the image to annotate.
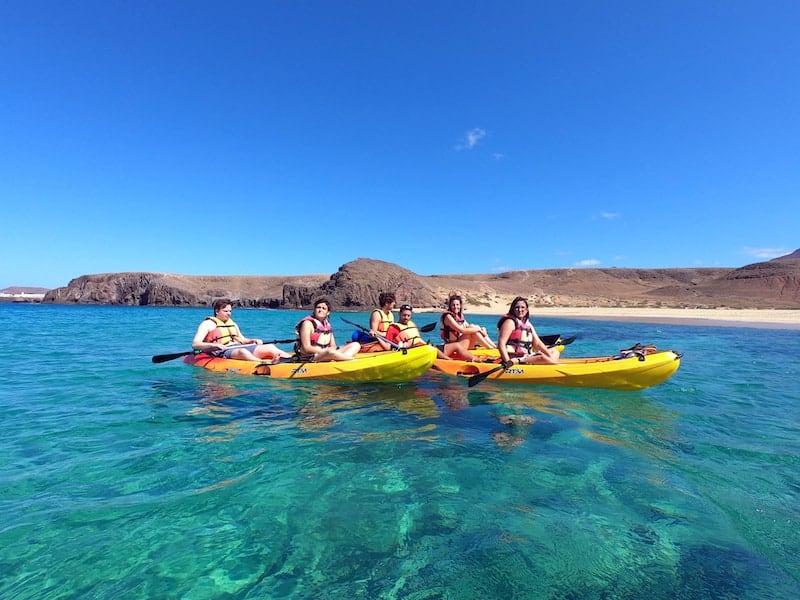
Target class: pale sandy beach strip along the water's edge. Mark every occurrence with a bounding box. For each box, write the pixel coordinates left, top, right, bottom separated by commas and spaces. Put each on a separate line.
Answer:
416, 303, 800, 331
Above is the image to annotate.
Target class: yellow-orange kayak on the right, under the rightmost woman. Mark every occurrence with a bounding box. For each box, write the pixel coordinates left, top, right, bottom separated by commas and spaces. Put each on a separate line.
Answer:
433, 350, 681, 390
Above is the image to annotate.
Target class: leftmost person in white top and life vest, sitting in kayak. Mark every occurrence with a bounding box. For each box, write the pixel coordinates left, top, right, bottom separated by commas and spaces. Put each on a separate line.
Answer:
192, 298, 293, 361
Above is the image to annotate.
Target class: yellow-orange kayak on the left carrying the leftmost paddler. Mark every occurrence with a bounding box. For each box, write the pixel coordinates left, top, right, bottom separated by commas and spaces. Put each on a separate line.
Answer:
183, 346, 436, 383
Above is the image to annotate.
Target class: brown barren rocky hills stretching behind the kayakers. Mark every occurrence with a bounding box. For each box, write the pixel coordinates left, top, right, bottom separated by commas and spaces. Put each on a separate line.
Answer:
44, 251, 800, 311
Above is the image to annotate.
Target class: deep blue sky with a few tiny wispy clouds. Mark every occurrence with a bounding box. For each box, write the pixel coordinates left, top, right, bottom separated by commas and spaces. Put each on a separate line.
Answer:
0, 0, 800, 288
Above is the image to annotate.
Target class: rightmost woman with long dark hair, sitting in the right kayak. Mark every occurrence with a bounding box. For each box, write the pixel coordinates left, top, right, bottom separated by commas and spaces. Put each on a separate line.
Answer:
497, 296, 561, 366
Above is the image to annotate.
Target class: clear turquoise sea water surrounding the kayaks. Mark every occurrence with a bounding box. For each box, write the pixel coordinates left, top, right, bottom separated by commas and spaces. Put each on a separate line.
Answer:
0, 304, 800, 599
